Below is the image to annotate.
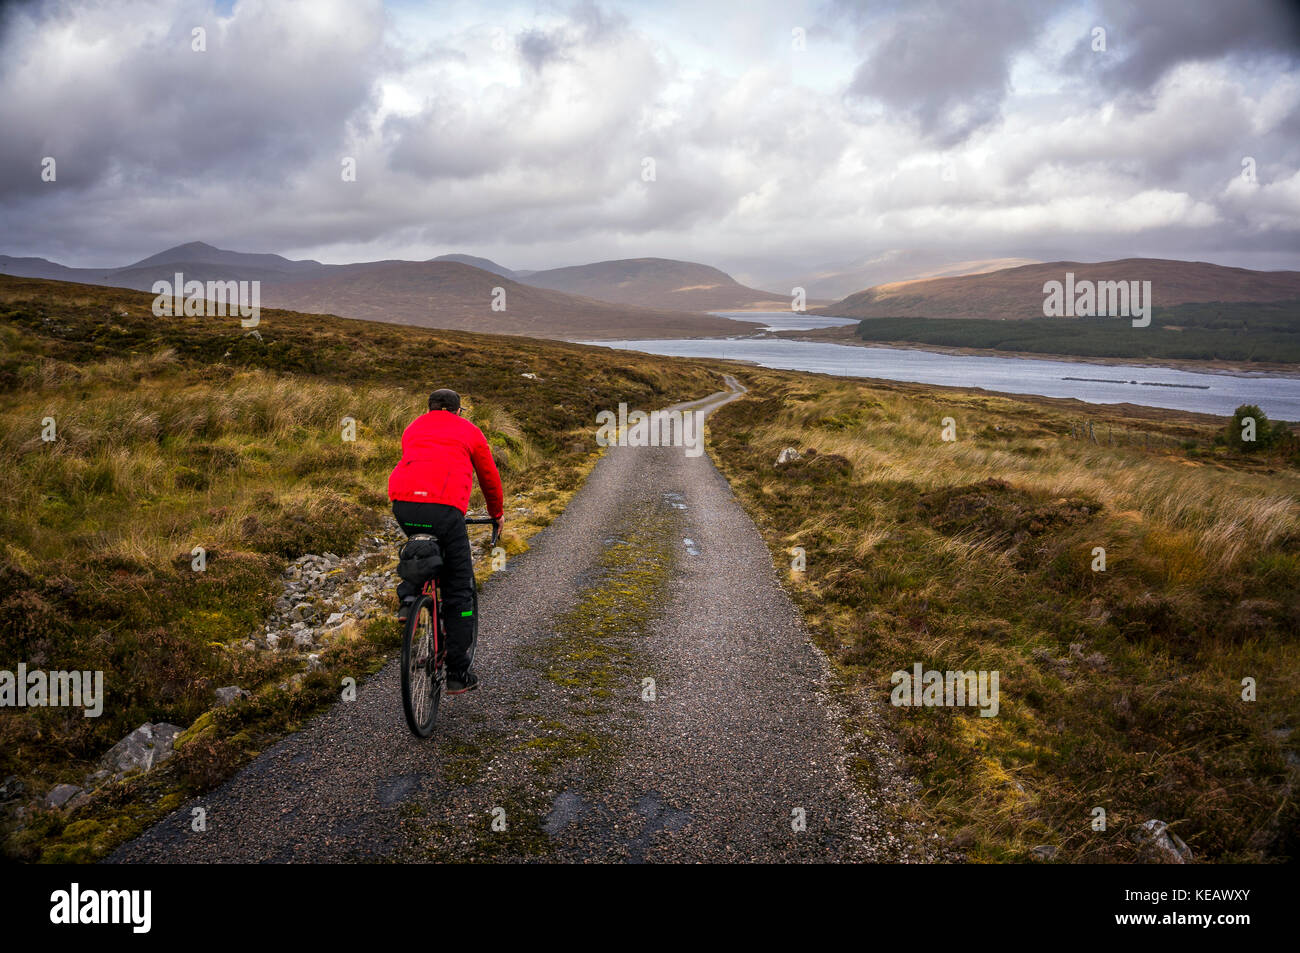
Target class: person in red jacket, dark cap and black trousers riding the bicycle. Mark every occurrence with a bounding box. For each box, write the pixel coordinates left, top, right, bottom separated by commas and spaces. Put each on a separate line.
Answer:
389, 390, 506, 694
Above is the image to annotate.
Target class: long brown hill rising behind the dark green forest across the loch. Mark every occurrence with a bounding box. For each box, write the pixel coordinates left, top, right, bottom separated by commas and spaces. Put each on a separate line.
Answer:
814, 259, 1300, 320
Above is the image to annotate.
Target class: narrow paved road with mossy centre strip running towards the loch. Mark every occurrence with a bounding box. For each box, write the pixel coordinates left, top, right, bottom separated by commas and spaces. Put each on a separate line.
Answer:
112, 378, 917, 862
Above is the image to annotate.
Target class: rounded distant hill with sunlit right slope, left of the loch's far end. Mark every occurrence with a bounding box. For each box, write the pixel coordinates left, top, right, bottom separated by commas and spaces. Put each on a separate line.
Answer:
523, 259, 790, 311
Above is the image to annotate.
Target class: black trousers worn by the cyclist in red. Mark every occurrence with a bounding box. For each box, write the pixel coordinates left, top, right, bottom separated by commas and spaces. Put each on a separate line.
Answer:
393, 499, 475, 672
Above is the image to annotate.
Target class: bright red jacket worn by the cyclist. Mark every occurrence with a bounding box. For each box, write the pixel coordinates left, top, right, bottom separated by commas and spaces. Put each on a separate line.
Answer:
389, 411, 502, 519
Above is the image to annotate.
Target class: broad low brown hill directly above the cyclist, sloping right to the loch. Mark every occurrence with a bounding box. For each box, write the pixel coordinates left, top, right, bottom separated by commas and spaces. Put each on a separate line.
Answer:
261, 261, 758, 339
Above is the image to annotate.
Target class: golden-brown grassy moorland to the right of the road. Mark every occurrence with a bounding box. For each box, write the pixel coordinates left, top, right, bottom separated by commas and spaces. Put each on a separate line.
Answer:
711, 372, 1300, 861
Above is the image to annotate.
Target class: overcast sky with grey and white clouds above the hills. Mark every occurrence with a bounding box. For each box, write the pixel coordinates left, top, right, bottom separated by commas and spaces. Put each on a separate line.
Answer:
0, 0, 1300, 290
